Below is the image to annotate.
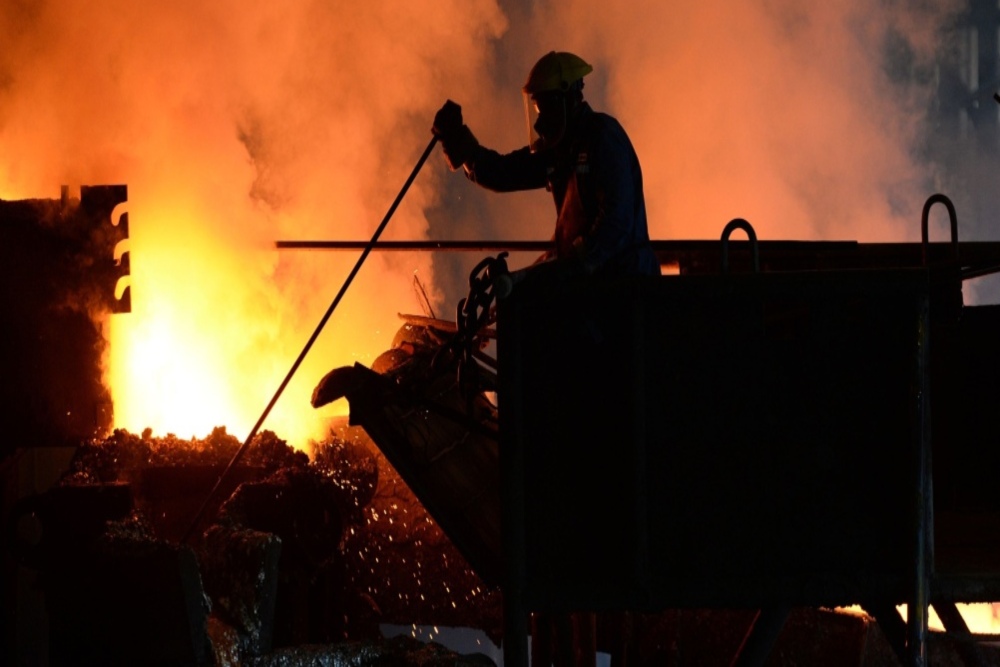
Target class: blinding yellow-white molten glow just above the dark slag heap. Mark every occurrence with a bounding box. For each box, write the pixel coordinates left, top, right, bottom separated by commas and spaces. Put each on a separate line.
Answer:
101, 201, 360, 448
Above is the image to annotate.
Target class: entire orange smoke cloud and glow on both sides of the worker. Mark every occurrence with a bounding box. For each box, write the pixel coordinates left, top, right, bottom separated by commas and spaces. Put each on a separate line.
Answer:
0, 0, 957, 448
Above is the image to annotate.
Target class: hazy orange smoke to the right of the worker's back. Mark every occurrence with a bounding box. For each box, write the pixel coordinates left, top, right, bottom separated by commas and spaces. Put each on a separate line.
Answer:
436, 0, 959, 253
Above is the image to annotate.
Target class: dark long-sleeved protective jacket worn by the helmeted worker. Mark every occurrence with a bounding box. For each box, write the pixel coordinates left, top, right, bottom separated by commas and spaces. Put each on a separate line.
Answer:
465, 102, 660, 275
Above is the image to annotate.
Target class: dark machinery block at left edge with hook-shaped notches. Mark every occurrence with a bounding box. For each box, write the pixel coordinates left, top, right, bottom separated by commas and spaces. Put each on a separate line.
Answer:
0, 185, 131, 460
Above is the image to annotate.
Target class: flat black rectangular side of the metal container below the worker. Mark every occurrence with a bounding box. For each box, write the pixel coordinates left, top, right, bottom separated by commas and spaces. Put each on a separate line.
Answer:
498, 270, 930, 611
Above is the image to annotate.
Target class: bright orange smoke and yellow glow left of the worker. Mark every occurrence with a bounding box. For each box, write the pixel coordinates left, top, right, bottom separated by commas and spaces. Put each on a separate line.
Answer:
0, 0, 505, 444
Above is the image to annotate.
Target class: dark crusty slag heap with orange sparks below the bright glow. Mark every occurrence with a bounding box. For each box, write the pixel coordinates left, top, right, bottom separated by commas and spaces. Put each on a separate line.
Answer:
20, 427, 501, 664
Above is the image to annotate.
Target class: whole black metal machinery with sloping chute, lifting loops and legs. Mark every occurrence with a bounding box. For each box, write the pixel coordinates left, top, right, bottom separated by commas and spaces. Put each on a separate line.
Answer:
326, 195, 1000, 665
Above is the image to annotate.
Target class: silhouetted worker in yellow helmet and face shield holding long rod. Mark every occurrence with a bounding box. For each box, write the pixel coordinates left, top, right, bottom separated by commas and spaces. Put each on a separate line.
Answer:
432, 51, 660, 275
